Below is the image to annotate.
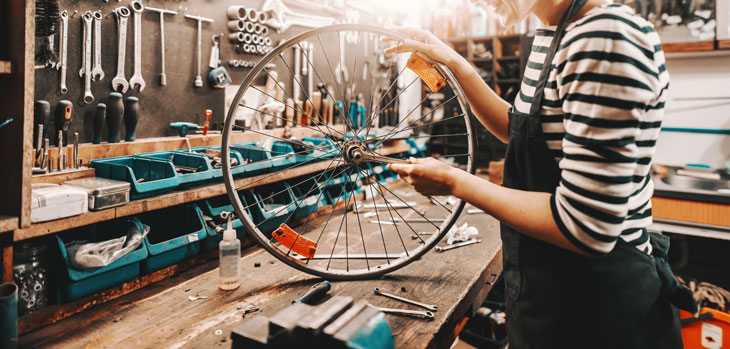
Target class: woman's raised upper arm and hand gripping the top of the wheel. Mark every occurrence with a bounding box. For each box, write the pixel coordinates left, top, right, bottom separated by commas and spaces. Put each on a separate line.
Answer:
386, 28, 510, 143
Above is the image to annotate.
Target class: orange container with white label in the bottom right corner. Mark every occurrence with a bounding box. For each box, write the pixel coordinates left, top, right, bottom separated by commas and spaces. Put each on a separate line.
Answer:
679, 308, 730, 349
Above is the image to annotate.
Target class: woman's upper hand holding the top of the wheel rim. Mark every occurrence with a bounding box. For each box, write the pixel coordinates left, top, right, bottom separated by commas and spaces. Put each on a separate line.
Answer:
382, 28, 463, 70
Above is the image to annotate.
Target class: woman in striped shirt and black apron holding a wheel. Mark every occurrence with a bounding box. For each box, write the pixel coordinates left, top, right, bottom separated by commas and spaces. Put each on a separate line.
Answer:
389, 0, 696, 349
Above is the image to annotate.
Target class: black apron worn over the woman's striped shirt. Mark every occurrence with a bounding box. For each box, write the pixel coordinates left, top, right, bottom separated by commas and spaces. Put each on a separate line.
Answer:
501, 0, 696, 349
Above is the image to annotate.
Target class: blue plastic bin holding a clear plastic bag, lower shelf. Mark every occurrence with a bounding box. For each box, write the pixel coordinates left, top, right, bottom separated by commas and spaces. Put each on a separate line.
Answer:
56, 218, 147, 302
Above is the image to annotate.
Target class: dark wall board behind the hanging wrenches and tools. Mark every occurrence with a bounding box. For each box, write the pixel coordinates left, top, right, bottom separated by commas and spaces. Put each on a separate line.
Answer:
34, 0, 364, 143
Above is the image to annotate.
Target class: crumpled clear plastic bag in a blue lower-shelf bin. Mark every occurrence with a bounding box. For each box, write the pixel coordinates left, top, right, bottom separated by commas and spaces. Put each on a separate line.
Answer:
66, 224, 150, 270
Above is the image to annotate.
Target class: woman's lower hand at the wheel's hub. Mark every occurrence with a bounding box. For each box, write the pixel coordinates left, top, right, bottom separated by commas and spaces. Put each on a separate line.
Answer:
388, 158, 457, 195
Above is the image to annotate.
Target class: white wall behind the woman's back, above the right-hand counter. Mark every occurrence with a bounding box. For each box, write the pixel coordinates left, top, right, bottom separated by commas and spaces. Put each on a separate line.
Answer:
654, 51, 730, 168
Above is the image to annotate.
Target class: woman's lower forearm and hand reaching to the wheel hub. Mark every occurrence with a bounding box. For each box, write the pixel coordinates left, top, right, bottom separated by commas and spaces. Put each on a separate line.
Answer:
389, 158, 588, 255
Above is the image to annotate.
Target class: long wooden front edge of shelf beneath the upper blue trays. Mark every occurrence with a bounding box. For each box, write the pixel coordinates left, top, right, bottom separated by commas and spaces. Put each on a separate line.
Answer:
13, 141, 410, 241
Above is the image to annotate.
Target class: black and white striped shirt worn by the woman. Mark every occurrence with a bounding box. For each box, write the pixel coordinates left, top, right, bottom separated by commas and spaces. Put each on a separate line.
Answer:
515, 4, 669, 255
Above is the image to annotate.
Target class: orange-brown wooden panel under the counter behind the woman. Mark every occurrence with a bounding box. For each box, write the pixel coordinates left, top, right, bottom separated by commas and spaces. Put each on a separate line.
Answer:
651, 196, 730, 227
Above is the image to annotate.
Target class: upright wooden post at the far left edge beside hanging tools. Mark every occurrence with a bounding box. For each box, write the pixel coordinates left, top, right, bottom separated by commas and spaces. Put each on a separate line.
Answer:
0, 0, 35, 227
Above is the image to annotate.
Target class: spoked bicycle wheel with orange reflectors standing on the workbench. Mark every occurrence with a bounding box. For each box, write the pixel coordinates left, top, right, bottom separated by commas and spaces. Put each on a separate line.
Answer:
221, 24, 476, 280
